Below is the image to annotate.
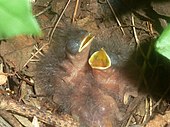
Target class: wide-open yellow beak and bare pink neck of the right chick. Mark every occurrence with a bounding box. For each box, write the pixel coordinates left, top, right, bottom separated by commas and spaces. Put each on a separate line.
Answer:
88, 48, 124, 96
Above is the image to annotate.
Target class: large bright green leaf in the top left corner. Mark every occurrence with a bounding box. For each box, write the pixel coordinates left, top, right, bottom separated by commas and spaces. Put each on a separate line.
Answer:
0, 0, 41, 39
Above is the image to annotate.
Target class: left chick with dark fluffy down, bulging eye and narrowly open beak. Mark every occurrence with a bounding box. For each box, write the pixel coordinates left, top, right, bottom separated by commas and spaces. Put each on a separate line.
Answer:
35, 27, 94, 106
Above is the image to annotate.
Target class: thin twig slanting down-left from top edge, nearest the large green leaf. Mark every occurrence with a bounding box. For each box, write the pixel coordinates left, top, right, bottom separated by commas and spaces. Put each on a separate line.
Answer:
49, 0, 71, 42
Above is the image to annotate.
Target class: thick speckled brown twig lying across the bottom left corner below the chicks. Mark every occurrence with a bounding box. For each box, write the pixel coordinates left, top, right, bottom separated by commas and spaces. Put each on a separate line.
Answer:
0, 95, 79, 127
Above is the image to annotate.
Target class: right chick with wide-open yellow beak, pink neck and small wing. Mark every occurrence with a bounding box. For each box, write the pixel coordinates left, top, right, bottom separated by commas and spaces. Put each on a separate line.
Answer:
88, 48, 137, 102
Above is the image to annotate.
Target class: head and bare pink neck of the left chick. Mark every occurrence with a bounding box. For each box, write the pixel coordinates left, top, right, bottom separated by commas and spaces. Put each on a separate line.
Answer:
62, 31, 94, 84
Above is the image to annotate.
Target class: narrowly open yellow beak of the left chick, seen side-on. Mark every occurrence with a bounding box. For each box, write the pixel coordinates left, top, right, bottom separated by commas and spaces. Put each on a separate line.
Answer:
78, 33, 94, 52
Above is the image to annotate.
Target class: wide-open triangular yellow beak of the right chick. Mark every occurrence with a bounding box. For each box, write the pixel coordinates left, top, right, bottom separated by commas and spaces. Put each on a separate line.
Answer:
88, 48, 111, 70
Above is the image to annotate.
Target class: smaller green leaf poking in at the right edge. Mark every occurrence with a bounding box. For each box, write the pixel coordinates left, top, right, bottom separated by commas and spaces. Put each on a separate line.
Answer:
155, 25, 170, 59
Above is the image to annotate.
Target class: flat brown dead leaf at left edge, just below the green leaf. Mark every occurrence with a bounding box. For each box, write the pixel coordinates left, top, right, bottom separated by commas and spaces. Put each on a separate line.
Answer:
0, 36, 35, 70
